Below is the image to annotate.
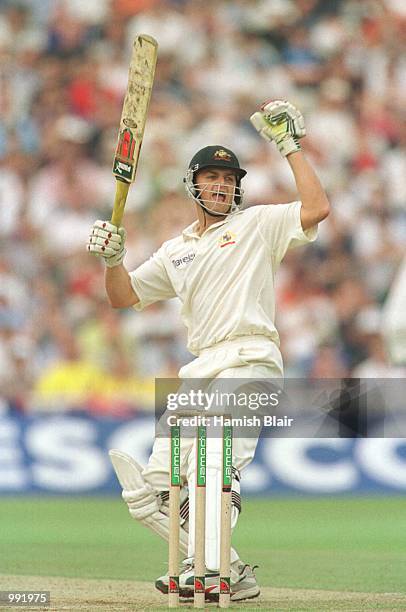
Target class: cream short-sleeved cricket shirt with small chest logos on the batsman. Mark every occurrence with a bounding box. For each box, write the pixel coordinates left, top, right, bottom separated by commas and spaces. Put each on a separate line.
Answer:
130, 202, 317, 355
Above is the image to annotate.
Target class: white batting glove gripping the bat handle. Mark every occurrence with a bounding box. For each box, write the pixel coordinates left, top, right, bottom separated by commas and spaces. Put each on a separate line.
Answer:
86, 221, 126, 268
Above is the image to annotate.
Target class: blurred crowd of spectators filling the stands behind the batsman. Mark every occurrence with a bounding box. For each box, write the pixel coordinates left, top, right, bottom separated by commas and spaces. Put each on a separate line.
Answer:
0, 0, 406, 413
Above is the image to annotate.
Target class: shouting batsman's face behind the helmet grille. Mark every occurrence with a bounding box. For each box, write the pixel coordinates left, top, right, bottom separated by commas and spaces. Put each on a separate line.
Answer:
195, 167, 237, 213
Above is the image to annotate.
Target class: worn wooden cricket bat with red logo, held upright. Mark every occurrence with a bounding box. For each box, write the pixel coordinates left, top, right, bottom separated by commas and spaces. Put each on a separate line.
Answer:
111, 34, 158, 227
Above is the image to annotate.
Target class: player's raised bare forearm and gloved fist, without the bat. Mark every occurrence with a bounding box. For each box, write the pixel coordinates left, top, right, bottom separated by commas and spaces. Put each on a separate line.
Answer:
251, 100, 330, 230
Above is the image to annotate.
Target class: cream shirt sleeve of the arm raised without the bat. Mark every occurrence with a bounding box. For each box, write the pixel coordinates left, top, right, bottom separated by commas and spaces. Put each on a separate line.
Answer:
259, 201, 317, 263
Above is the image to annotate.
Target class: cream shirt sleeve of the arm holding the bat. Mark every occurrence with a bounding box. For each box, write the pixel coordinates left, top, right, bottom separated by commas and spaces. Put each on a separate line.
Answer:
130, 247, 176, 310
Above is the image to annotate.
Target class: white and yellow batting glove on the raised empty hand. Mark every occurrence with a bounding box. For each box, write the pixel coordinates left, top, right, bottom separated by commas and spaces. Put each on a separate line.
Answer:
250, 100, 306, 157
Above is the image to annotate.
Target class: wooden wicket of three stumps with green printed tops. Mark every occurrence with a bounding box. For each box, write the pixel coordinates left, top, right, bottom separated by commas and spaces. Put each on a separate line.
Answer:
168, 411, 233, 608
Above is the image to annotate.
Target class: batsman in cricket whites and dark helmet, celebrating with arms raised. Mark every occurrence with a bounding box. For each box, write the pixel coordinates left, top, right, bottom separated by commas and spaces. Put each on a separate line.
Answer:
87, 100, 329, 601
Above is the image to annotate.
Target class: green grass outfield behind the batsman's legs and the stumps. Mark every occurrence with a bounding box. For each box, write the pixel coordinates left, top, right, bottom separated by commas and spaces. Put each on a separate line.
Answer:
0, 497, 406, 609
